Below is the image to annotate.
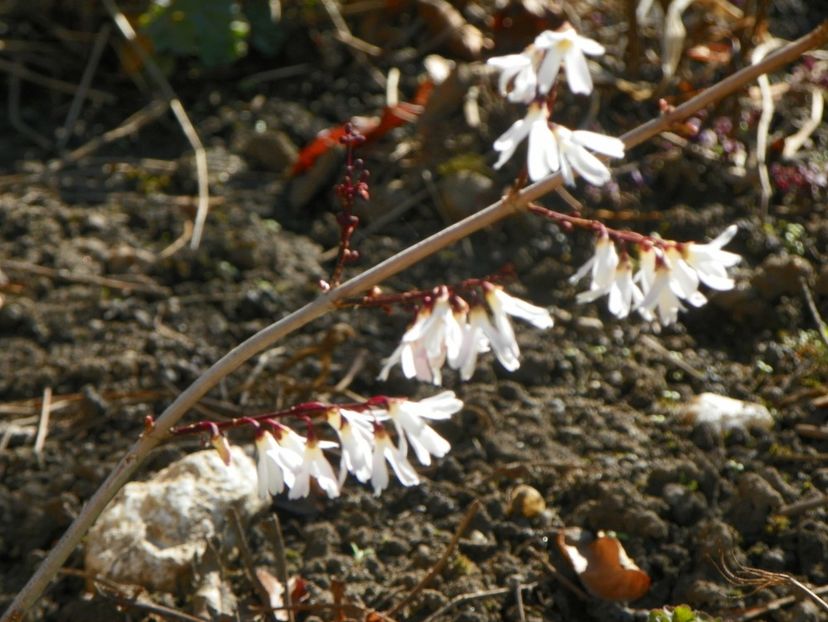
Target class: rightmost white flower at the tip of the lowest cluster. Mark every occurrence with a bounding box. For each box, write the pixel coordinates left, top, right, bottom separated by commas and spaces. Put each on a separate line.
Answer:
387, 391, 463, 466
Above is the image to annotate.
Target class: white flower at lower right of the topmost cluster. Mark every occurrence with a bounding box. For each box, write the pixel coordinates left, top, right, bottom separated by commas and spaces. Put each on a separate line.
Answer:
552, 125, 624, 186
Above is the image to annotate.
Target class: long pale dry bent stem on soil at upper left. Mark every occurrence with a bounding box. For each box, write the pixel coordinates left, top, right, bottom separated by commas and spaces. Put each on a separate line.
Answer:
103, 0, 210, 249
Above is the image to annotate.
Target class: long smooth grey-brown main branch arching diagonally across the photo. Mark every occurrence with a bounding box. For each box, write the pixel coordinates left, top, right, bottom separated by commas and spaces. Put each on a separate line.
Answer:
6, 21, 828, 622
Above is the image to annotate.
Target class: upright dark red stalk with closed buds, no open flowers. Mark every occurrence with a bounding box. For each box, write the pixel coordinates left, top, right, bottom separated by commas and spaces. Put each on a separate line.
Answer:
322, 123, 369, 291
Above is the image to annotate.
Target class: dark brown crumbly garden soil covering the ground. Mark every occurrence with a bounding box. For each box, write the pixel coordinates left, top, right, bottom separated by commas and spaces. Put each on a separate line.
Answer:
0, 2, 828, 622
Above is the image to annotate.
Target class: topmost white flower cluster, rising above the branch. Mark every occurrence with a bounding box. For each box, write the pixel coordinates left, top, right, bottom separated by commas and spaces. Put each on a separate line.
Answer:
488, 24, 624, 186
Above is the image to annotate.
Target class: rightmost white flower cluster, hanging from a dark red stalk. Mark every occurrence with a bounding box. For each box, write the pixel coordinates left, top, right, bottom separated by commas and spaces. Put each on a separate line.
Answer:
570, 225, 741, 326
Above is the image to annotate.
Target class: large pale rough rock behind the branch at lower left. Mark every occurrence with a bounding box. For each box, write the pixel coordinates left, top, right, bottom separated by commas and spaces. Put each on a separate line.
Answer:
86, 447, 265, 592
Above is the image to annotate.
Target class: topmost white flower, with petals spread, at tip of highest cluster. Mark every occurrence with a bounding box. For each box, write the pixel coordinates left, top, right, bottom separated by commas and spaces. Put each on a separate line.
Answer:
535, 26, 604, 95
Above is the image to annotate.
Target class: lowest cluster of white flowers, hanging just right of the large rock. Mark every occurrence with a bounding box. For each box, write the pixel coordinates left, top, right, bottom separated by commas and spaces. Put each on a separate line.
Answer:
254, 391, 463, 499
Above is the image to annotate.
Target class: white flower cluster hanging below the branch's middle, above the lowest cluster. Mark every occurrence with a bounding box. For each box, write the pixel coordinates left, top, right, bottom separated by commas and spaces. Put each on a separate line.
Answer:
379, 281, 553, 385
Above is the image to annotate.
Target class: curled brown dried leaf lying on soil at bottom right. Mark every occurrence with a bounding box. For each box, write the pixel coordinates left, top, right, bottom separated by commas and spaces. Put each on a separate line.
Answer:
558, 527, 651, 601
